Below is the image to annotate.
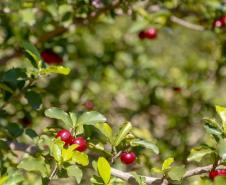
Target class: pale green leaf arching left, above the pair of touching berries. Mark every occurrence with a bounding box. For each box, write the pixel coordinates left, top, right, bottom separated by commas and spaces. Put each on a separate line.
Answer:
45, 107, 73, 129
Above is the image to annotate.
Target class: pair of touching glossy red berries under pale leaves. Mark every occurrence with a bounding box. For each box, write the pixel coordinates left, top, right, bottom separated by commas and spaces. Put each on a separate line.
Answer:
56, 129, 88, 152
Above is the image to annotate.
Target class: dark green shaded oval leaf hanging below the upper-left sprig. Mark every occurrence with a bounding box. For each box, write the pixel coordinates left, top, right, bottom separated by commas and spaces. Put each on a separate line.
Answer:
25, 91, 42, 109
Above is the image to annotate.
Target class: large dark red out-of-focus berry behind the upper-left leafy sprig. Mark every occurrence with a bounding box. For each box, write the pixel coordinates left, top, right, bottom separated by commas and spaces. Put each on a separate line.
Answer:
41, 50, 63, 65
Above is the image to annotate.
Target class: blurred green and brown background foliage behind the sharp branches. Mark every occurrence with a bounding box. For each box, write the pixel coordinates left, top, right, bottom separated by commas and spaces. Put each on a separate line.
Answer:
0, 0, 226, 185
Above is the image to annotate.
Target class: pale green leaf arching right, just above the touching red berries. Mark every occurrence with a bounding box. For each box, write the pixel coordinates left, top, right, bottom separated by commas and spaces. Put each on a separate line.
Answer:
77, 111, 106, 125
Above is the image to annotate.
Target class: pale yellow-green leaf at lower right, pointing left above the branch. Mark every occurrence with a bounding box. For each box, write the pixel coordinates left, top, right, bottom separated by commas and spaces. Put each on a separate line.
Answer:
188, 147, 214, 162
